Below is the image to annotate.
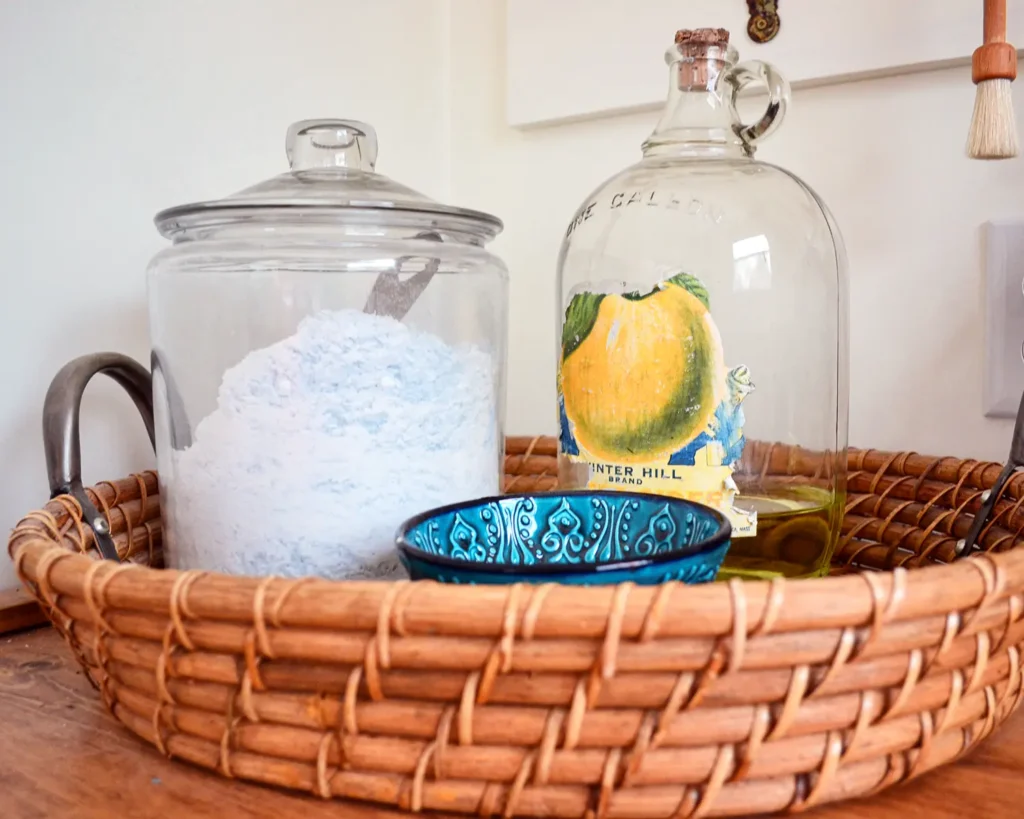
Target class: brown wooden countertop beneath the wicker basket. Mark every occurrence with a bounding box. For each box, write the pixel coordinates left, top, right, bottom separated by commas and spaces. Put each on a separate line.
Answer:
0, 629, 1024, 819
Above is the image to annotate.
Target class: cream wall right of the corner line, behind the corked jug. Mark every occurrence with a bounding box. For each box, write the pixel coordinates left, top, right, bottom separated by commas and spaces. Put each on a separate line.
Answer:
451, 0, 1024, 459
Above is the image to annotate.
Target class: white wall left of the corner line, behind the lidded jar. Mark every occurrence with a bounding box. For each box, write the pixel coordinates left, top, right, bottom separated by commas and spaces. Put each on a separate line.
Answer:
0, 0, 447, 589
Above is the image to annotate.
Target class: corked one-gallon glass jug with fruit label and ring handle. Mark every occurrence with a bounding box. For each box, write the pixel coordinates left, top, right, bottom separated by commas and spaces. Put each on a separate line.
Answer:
557, 29, 848, 577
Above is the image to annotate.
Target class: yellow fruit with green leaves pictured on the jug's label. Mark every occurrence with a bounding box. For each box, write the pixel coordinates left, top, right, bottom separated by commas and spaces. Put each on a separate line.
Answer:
560, 273, 725, 463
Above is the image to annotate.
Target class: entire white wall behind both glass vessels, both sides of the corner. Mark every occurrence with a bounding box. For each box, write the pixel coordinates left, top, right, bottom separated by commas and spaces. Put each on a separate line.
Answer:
0, 0, 1024, 588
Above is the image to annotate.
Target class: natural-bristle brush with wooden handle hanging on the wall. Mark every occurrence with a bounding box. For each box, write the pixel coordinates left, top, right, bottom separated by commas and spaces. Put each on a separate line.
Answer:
967, 0, 1017, 160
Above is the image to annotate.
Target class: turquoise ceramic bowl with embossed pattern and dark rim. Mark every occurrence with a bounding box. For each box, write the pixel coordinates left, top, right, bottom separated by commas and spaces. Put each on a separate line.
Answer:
397, 491, 732, 586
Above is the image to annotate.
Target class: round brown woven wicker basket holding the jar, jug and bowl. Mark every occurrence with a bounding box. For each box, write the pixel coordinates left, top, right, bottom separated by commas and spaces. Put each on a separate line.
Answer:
10, 362, 1024, 819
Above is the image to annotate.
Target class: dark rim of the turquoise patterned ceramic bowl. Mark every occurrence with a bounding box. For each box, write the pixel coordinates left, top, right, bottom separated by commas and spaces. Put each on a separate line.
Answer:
395, 489, 732, 574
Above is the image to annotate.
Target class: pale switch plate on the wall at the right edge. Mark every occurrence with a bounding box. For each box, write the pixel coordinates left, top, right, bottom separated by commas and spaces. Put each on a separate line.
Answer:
982, 220, 1024, 418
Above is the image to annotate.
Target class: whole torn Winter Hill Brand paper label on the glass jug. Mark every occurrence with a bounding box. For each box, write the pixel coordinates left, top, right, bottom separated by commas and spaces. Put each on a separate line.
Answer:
558, 273, 757, 536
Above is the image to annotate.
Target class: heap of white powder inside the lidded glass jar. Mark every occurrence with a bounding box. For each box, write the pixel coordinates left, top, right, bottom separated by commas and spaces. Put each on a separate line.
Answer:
165, 310, 500, 578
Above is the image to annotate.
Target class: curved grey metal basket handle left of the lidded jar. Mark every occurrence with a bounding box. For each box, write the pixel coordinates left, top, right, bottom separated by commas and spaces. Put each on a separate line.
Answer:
43, 352, 155, 560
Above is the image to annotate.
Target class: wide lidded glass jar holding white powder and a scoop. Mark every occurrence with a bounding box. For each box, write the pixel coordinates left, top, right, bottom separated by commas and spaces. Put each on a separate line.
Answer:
148, 120, 507, 577
